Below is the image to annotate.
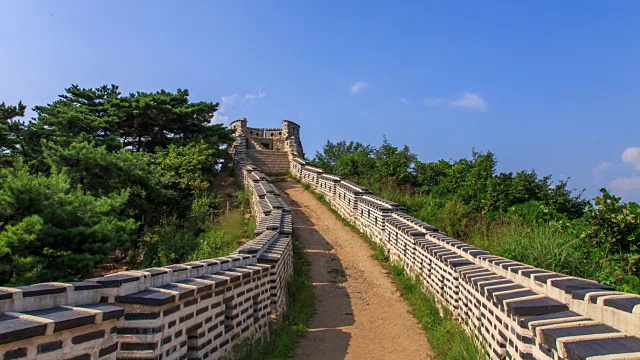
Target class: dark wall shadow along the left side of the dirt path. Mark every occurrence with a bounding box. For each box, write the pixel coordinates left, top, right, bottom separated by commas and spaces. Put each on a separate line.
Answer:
275, 181, 354, 360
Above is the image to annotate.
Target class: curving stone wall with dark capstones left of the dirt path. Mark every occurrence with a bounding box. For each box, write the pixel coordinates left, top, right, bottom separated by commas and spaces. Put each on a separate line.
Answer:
0, 157, 293, 360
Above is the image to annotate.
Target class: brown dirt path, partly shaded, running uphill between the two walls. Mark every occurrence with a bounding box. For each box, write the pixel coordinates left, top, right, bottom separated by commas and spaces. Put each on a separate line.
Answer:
277, 181, 434, 360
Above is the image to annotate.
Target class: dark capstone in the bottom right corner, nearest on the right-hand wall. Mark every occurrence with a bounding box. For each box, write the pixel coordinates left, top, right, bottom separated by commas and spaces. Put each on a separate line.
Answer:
565, 337, 640, 360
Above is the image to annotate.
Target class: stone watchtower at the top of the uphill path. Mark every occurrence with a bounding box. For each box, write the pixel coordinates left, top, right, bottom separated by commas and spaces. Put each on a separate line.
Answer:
230, 119, 304, 175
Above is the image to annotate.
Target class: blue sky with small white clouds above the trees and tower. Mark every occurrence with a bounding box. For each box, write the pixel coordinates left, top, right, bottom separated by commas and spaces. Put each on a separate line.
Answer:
0, 0, 640, 201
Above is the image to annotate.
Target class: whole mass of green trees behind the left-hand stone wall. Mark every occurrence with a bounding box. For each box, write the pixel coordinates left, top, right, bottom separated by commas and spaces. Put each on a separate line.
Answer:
0, 85, 235, 285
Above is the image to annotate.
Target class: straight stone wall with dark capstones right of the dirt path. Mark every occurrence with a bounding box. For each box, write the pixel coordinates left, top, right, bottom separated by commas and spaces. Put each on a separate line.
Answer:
291, 158, 640, 360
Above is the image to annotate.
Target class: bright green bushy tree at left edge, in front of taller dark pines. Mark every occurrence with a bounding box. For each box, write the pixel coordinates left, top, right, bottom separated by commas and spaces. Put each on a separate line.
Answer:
0, 164, 137, 284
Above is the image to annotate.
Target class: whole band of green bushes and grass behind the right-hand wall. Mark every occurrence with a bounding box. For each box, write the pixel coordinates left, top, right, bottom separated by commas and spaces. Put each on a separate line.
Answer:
312, 139, 640, 292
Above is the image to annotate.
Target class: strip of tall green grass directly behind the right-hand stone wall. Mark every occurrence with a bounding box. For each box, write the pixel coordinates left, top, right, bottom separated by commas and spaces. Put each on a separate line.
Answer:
357, 178, 614, 285
